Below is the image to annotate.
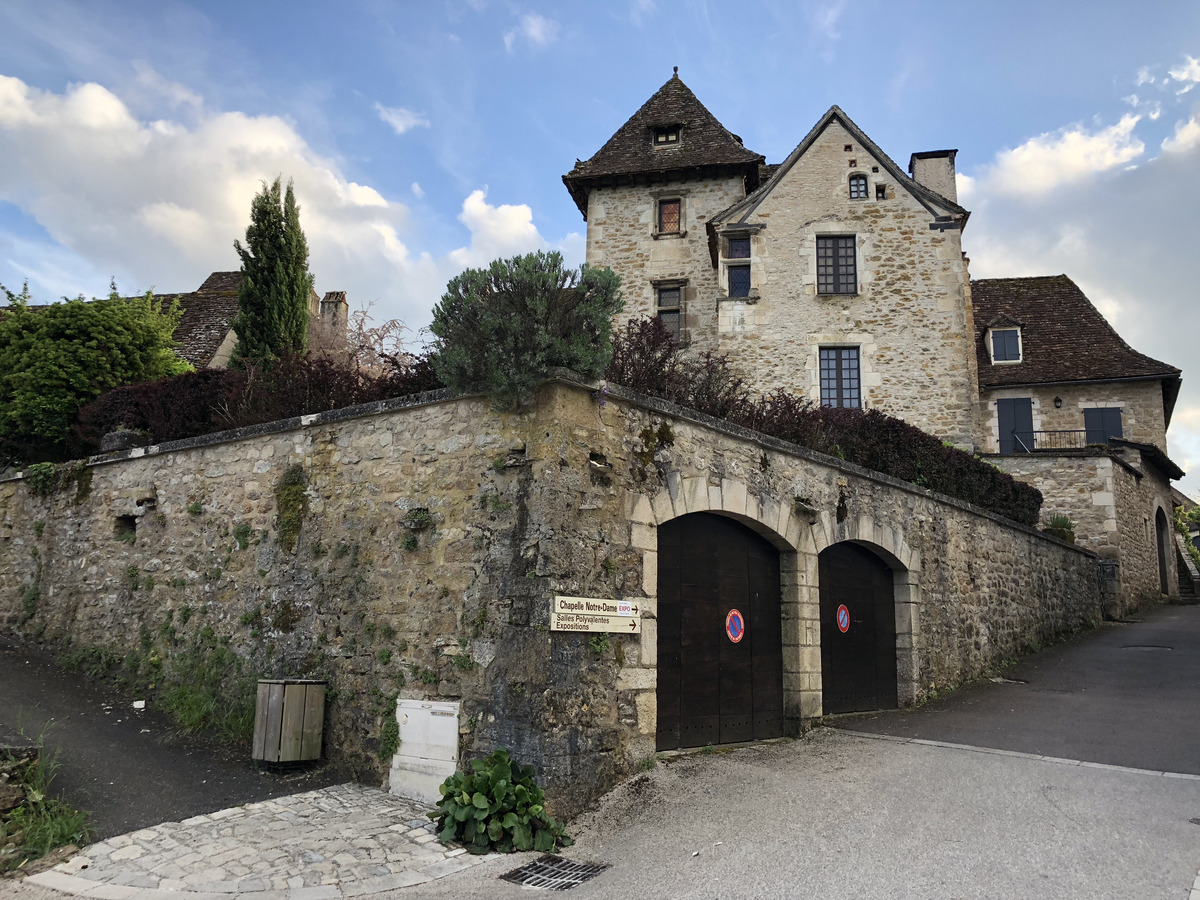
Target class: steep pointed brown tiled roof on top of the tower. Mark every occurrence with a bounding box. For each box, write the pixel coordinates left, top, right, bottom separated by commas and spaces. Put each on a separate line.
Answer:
563, 72, 764, 218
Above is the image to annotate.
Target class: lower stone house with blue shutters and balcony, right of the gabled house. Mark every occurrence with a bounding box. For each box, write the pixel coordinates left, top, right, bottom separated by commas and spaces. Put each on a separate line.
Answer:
971, 275, 1183, 613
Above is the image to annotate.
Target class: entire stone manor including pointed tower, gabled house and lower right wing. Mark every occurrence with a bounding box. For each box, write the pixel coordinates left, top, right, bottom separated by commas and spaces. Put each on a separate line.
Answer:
563, 72, 1182, 614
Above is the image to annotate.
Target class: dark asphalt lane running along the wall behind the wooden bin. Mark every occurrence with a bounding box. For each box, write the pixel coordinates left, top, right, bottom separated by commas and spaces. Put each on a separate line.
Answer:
0, 638, 346, 840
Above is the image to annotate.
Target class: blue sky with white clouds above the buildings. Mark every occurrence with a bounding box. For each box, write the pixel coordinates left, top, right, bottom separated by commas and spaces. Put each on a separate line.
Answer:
0, 0, 1200, 494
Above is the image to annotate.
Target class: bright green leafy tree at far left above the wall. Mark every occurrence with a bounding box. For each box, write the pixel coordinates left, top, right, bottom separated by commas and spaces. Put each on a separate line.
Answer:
0, 283, 192, 446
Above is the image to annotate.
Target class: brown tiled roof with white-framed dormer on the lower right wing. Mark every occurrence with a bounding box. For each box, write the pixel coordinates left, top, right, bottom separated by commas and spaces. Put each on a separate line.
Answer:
971, 275, 1180, 421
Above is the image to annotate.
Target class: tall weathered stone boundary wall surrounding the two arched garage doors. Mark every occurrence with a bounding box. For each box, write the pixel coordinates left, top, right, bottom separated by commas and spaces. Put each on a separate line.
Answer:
0, 378, 1099, 815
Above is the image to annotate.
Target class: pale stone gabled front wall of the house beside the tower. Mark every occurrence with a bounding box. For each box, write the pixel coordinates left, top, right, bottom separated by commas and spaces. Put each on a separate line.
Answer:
721, 121, 977, 446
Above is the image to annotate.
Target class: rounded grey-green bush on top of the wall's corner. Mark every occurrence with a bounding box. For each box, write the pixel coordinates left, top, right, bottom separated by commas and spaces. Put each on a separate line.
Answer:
430, 252, 622, 409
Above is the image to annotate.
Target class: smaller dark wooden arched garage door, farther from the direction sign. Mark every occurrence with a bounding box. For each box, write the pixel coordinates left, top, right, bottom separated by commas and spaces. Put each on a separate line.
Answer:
817, 544, 896, 715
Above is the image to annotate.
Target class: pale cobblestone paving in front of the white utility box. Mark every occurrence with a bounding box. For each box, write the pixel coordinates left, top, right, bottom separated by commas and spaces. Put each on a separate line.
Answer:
26, 785, 486, 900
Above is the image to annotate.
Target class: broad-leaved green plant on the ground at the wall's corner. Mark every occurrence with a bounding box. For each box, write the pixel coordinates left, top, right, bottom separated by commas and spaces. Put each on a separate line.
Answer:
430, 748, 574, 853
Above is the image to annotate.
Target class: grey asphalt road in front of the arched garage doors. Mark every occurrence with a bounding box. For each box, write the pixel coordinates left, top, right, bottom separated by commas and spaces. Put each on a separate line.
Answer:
9, 607, 1200, 900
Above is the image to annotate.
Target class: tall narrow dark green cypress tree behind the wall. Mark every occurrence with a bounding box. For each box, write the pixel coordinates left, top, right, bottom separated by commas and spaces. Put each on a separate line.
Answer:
233, 178, 312, 365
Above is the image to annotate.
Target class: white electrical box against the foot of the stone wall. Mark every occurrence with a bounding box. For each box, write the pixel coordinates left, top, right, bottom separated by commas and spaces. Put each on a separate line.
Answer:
389, 700, 461, 803
